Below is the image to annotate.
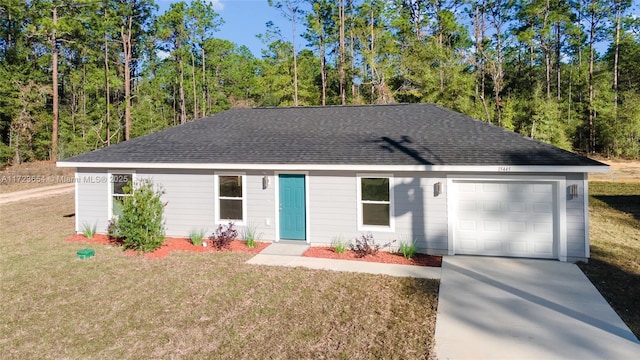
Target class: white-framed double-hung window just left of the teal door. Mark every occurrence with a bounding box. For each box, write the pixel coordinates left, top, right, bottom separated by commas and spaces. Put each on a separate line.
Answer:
216, 174, 246, 222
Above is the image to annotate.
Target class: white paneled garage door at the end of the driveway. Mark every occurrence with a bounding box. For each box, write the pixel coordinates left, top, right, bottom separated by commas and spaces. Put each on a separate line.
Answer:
454, 181, 556, 258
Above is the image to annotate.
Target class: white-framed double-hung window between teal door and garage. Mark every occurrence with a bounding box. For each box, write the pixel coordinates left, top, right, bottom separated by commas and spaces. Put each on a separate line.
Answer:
358, 175, 393, 230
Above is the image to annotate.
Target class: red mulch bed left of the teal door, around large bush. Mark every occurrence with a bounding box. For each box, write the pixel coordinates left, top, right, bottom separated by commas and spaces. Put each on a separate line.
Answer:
65, 234, 270, 259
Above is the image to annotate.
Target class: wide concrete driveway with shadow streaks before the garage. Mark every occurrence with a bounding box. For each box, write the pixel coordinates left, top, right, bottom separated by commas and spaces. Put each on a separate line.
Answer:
435, 256, 640, 360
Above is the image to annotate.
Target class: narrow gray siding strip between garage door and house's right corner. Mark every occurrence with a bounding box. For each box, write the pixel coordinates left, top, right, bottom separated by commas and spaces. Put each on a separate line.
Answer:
566, 174, 585, 258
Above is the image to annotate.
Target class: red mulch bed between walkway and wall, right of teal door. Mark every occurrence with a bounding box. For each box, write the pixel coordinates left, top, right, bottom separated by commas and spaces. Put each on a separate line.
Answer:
302, 246, 442, 267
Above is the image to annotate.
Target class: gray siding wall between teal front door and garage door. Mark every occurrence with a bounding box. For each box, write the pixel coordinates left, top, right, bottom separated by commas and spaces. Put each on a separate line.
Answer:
309, 172, 448, 252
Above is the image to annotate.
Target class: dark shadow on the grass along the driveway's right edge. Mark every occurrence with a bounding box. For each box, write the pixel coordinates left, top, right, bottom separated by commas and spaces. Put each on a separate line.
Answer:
577, 258, 640, 339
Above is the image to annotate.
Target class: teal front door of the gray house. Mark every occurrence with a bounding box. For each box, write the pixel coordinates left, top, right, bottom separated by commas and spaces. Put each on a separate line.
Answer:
278, 174, 307, 240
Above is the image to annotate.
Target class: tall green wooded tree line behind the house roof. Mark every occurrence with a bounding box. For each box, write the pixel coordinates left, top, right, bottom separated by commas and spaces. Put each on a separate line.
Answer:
0, 0, 640, 163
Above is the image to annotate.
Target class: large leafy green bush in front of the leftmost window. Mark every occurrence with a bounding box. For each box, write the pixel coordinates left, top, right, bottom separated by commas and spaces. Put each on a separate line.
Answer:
109, 179, 166, 252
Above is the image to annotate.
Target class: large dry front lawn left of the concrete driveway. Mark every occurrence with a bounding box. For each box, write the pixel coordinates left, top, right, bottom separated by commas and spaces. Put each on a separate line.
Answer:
0, 195, 438, 359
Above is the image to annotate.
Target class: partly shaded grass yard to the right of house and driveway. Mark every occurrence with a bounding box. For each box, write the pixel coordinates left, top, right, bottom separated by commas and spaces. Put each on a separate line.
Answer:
580, 182, 640, 337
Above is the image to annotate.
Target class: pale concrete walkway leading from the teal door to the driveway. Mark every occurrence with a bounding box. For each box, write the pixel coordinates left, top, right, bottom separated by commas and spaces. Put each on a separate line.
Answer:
247, 242, 440, 279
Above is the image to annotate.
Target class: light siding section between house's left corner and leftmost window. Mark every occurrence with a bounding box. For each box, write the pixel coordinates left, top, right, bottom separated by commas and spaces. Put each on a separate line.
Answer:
75, 168, 109, 233
